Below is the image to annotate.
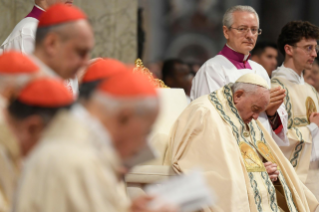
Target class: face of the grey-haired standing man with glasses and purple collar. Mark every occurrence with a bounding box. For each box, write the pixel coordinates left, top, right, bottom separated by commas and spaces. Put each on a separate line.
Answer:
223, 12, 259, 55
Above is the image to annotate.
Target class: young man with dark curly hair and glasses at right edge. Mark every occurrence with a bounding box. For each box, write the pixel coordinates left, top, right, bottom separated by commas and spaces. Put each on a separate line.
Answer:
271, 21, 319, 198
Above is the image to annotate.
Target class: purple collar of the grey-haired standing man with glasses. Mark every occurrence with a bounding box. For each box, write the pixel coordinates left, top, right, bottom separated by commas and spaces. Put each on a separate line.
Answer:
218, 44, 252, 69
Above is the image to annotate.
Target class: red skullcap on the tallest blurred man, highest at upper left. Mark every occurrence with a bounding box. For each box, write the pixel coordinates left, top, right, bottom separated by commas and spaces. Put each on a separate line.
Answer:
38, 4, 87, 27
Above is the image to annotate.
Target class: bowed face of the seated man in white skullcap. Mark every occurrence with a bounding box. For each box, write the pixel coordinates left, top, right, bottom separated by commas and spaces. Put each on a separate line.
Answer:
233, 87, 270, 124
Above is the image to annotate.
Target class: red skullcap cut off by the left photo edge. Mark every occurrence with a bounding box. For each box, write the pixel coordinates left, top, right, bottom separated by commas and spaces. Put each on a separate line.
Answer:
0, 51, 39, 75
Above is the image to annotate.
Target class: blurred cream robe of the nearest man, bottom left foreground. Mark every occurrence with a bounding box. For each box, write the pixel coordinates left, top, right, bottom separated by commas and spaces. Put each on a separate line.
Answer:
13, 105, 130, 212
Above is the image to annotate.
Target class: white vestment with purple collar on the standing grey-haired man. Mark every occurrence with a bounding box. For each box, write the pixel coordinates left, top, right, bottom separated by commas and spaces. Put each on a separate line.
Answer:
191, 45, 289, 146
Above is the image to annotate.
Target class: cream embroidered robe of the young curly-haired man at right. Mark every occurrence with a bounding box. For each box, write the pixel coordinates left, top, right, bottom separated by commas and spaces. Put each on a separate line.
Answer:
271, 77, 319, 183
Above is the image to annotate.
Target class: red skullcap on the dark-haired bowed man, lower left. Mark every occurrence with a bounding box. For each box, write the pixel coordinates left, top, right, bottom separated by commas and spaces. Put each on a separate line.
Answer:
17, 78, 74, 108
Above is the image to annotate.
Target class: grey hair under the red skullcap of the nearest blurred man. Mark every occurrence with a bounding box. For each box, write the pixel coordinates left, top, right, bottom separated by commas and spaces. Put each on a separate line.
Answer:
92, 91, 159, 116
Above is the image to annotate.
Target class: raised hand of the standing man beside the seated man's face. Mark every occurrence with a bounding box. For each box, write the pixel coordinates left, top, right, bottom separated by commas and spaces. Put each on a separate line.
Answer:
266, 86, 286, 116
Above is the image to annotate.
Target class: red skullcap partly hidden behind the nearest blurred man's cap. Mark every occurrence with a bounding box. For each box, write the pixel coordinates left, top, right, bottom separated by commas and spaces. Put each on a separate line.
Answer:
82, 58, 128, 83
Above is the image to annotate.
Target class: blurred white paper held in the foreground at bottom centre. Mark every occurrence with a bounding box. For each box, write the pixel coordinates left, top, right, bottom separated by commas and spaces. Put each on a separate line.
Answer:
145, 171, 216, 212
